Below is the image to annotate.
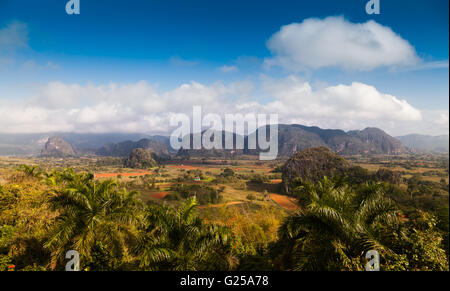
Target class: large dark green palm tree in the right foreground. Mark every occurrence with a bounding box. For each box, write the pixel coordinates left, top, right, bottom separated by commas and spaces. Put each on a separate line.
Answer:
277, 178, 402, 270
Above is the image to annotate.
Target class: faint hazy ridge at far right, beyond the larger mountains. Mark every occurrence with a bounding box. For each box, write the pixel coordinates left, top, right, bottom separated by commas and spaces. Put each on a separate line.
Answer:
397, 134, 449, 153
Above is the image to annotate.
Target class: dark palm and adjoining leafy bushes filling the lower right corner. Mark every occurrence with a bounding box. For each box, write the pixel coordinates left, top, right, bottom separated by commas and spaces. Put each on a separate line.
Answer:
274, 178, 448, 270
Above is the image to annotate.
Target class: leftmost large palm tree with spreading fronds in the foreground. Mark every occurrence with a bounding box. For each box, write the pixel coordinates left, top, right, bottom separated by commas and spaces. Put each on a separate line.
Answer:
45, 171, 142, 265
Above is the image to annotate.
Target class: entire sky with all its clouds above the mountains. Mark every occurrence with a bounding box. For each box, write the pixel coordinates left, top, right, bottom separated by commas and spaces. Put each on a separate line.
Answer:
0, 0, 449, 135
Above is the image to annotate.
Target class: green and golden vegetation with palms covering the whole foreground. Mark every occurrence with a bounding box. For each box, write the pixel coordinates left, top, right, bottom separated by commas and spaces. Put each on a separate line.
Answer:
0, 149, 449, 271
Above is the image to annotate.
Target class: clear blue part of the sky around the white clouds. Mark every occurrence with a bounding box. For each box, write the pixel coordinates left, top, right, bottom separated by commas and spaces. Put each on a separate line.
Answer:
0, 0, 449, 134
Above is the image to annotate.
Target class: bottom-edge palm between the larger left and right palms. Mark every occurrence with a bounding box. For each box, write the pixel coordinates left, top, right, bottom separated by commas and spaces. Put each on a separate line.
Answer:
134, 198, 236, 271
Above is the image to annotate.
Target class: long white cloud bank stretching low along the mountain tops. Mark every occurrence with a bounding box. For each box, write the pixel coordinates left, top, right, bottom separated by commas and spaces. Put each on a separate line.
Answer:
0, 76, 440, 135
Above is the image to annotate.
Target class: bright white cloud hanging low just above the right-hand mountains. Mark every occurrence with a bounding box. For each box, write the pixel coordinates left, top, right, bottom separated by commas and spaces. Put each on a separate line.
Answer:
260, 76, 421, 122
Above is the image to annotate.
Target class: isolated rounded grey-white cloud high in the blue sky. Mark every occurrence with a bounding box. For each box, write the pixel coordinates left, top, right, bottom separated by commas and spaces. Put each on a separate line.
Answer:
265, 17, 420, 71
